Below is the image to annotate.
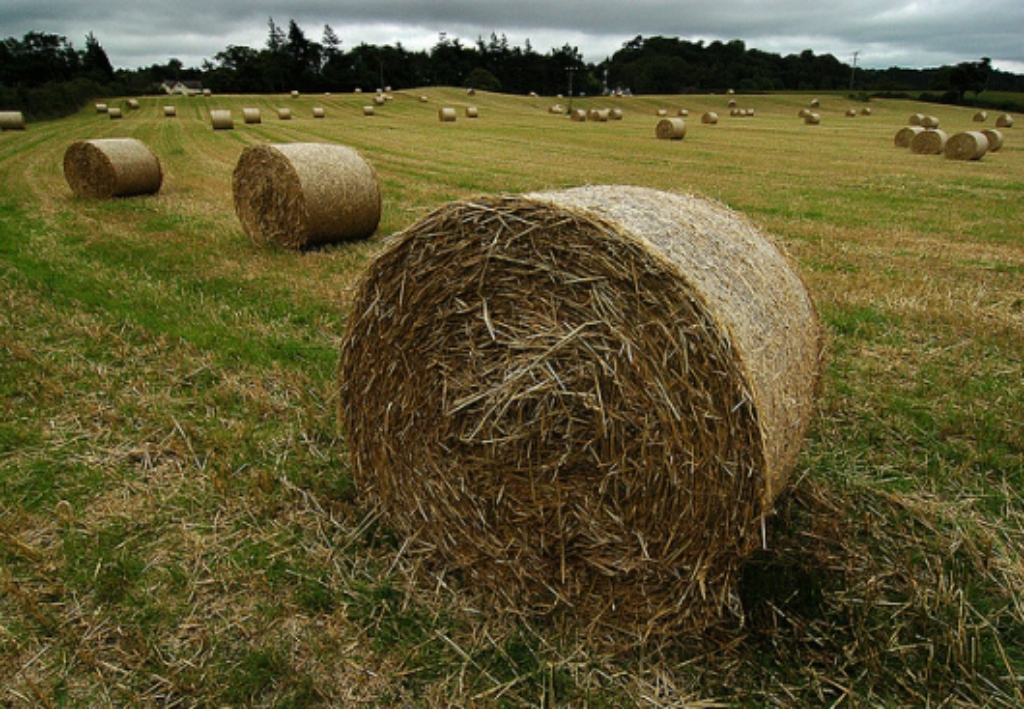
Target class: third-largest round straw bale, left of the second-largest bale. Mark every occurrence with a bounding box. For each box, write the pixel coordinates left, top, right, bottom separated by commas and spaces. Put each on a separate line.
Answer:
63, 138, 164, 200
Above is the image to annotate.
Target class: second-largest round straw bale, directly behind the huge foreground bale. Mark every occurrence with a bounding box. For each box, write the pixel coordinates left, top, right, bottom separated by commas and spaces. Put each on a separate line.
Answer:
231, 142, 381, 249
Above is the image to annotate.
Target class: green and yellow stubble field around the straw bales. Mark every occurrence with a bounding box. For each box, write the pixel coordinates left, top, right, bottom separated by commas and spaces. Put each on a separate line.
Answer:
0, 89, 1024, 708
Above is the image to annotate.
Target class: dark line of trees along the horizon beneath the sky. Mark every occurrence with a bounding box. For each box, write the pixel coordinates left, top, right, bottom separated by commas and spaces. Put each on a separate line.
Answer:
0, 17, 1024, 116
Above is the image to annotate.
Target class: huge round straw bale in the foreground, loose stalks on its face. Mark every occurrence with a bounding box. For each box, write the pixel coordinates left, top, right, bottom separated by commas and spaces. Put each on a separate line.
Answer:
339, 186, 821, 638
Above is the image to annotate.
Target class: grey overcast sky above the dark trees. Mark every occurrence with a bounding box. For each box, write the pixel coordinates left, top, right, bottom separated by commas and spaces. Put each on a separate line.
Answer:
6, 0, 1024, 73
